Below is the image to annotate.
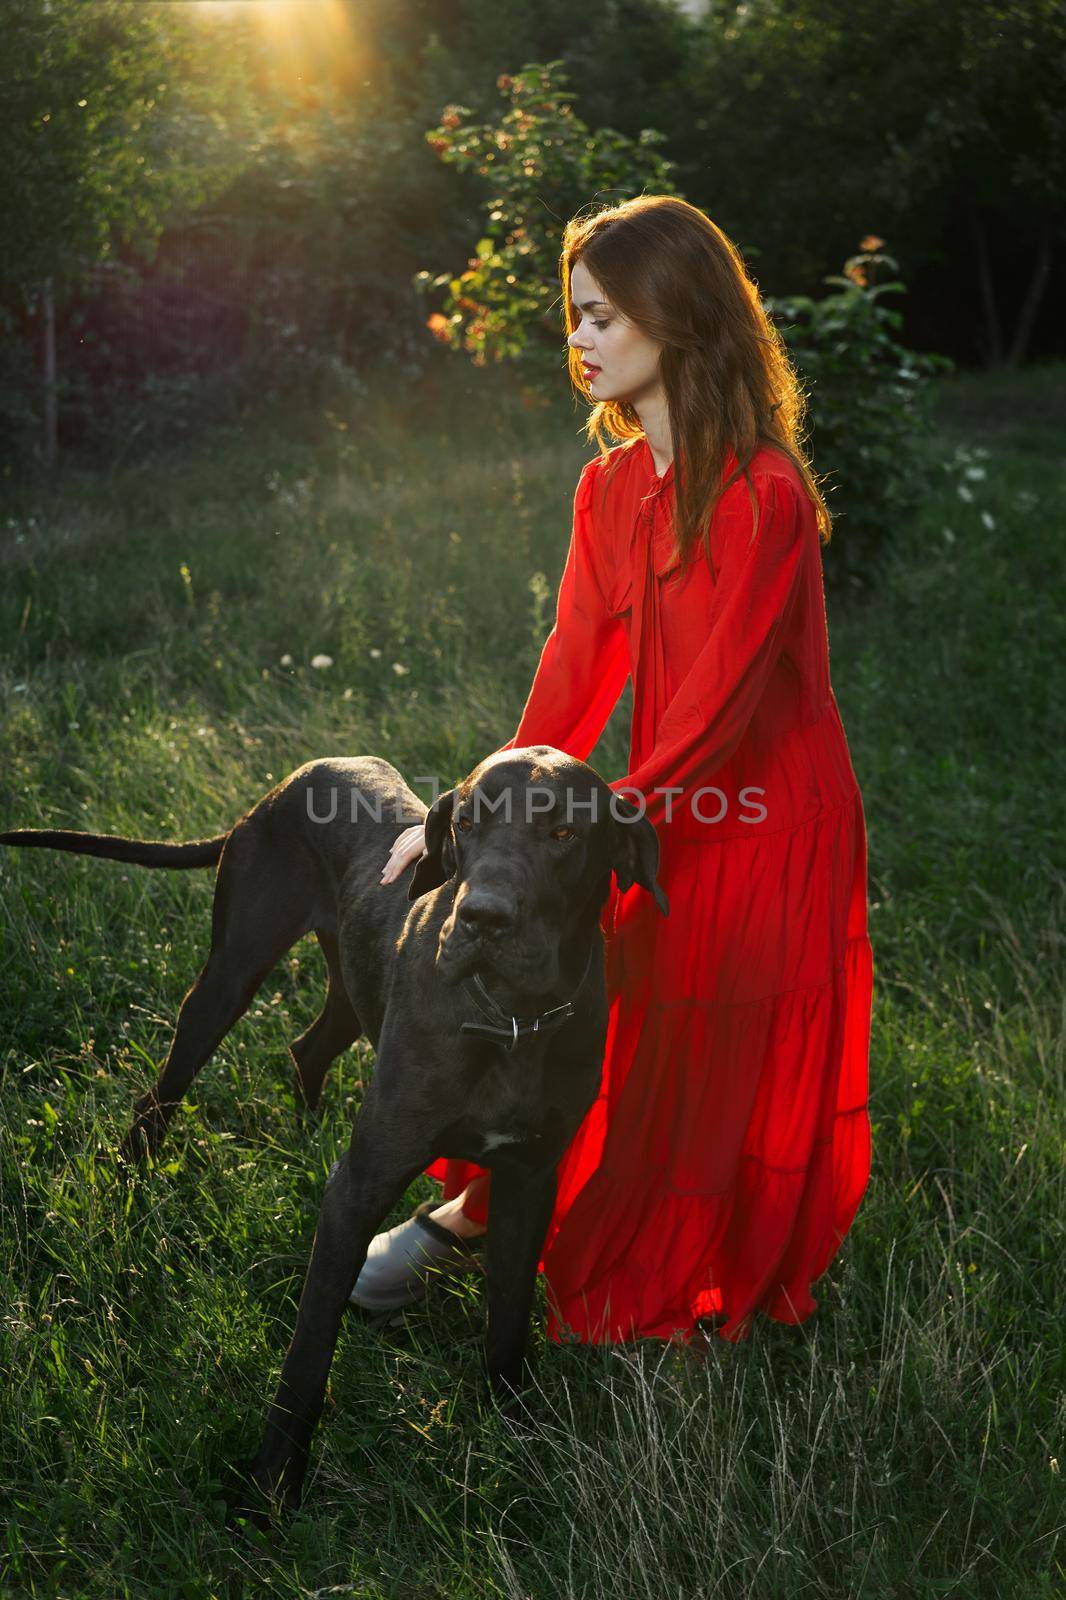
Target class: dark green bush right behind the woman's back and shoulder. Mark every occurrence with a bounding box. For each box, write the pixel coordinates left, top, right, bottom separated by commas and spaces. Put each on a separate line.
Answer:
767, 238, 954, 587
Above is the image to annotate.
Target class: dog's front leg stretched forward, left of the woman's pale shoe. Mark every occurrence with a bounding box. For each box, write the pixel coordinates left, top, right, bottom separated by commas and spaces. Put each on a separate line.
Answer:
242, 1110, 432, 1520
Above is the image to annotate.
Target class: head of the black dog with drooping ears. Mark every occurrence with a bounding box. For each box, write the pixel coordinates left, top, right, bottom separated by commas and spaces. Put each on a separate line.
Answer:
408, 744, 669, 992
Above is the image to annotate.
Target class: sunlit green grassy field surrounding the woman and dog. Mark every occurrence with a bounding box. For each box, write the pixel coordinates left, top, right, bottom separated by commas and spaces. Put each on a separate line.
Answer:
0, 366, 1066, 1600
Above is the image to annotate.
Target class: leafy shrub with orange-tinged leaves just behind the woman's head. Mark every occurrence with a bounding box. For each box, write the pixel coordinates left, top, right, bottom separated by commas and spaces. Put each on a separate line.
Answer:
416, 61, 672, 373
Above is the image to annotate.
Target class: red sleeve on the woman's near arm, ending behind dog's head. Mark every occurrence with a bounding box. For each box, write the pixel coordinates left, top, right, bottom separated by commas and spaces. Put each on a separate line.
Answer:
610, 474, 804, 827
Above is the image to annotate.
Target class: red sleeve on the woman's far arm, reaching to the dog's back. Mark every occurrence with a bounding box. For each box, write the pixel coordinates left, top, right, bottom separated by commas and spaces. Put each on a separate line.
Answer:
499, 461, 629, 762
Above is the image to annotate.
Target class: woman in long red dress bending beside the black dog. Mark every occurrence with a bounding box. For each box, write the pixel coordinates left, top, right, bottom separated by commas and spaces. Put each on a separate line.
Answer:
354, 197, 872, 1342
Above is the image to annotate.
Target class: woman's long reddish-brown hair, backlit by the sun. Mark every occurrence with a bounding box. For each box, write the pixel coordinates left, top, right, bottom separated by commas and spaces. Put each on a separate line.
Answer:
560, 195, 832, 565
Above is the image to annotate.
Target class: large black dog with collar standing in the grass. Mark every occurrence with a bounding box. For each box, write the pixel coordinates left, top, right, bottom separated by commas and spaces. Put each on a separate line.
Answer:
0, 746, 667, 1502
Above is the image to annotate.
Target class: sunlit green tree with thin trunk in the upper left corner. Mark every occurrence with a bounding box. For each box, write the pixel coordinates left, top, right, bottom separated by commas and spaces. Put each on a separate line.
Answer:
0, 0, 251, 466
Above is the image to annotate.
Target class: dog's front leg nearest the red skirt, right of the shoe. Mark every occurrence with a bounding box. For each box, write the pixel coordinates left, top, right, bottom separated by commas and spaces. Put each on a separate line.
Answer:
485, 1162, 555, 1414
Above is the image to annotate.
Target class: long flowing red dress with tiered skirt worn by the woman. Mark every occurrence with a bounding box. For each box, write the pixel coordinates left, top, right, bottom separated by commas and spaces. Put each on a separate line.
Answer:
426, 438, 872, 1344
